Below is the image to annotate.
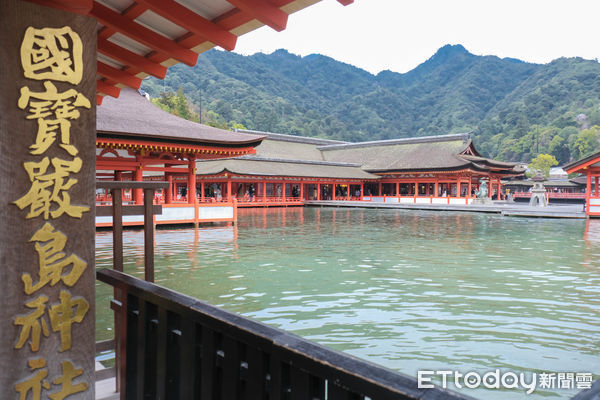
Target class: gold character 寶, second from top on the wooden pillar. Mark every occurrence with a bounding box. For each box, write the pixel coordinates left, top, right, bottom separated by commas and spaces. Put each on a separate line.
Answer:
17, 81, 91, 156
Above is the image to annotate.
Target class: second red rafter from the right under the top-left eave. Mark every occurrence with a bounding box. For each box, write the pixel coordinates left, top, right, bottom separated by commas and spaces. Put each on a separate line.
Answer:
136, 0, 237, 51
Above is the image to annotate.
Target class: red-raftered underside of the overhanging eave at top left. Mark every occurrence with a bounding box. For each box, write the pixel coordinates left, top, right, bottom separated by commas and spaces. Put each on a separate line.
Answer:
37, 0, 353, 104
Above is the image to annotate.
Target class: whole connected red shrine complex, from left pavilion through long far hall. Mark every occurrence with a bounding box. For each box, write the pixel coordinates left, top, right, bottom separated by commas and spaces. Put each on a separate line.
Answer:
96, 95, 524, 226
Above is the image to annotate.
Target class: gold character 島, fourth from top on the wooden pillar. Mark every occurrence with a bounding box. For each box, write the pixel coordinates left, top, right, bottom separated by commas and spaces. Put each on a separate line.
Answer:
21, 222, 87, 294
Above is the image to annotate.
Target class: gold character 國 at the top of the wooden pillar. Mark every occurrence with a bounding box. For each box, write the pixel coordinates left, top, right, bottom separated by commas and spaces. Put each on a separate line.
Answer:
21, 26, 83, 85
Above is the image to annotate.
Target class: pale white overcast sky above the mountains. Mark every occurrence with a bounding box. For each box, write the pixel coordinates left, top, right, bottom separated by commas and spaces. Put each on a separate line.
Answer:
235, 0, 600, 73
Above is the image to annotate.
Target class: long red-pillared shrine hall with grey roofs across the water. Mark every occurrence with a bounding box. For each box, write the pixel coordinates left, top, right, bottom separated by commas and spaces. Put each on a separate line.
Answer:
192, 131, 524, 207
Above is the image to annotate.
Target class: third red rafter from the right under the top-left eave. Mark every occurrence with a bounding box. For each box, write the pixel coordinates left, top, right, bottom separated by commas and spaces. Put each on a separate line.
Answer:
90, 2, 198, 67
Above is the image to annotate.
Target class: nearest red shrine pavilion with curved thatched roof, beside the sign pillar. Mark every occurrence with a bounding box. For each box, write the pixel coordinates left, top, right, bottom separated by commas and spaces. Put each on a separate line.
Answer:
96, 89, 263, 227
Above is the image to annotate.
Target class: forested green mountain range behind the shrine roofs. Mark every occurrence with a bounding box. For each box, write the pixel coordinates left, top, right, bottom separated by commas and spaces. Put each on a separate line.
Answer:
143, 45, 600, 162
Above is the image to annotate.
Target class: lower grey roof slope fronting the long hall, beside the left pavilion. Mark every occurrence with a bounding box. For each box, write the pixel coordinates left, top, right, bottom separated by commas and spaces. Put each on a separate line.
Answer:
196, 156, 379, 179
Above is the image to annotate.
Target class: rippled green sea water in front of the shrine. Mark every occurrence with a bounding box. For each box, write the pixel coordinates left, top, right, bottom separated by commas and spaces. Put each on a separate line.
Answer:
96, 208, 600, 399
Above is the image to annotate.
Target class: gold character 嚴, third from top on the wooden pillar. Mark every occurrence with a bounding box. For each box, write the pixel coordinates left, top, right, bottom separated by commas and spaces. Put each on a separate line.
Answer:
14, 157, 90, 219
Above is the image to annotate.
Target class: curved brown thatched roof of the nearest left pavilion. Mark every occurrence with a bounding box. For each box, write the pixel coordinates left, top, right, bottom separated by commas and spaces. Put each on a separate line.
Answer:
96, 89, 264, 147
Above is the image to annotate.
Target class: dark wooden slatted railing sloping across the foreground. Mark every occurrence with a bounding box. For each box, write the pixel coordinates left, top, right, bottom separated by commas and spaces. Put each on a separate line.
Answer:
97, 269, 469, 400
